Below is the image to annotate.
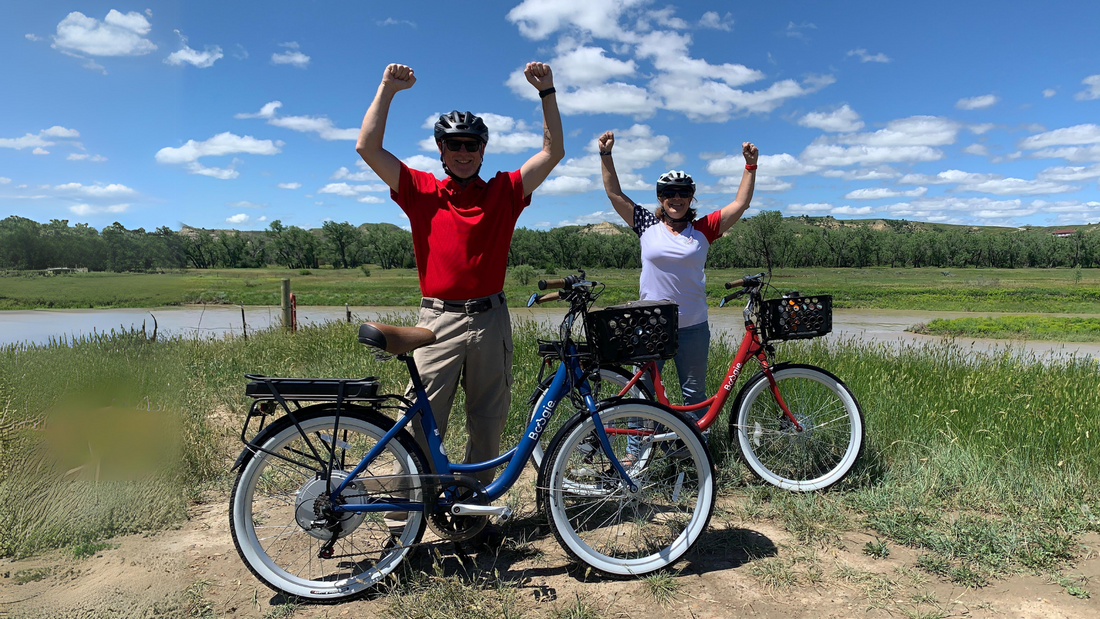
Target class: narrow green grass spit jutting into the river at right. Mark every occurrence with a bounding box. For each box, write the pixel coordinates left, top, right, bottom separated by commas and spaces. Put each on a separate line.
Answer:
909, 316, 1100, 342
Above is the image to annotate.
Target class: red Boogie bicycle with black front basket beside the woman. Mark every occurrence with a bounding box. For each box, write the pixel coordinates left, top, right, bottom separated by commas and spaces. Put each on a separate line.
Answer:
530, 273, 864, 491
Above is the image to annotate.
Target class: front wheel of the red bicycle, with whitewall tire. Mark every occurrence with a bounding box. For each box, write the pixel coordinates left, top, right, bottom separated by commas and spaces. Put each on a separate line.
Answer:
729, 364, 864, 493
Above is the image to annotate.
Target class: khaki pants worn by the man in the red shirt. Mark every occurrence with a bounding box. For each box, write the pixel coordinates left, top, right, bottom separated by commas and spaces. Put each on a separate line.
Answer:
408, 299, 513, 485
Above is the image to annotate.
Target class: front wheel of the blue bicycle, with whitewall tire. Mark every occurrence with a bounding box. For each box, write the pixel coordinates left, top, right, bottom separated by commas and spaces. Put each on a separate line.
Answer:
540, 400, 715, 576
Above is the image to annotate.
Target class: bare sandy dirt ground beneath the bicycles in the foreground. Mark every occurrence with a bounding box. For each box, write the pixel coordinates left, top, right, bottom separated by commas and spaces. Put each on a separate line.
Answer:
0, 496, 1100, 619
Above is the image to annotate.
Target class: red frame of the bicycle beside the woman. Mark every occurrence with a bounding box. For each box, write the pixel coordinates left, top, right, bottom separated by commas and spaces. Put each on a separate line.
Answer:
612, 298, 802, 433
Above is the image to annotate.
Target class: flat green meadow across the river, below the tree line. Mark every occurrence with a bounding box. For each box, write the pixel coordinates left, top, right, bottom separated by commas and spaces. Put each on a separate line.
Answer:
0, 267, 1100, 314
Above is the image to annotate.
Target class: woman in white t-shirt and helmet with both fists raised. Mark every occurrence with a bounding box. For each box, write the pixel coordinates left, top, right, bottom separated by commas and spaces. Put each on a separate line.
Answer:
600, 131, 760, 419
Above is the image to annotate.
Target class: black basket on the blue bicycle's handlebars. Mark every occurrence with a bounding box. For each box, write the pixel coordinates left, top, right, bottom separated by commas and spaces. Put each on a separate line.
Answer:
586, 300, 680, 363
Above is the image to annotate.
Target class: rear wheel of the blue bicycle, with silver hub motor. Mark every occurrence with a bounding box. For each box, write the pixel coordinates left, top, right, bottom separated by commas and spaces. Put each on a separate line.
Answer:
229, 409, 427, 601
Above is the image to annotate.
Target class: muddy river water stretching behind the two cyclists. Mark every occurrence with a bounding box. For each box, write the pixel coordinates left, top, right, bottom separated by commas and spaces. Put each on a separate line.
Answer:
0, 306, 1100, 357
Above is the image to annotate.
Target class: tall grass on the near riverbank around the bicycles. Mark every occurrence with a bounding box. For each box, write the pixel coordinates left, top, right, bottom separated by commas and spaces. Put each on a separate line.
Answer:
0, 313, 1100, 586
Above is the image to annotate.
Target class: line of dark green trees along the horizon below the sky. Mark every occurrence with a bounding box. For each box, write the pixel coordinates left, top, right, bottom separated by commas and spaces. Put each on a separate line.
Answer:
0, 211, 1100, 272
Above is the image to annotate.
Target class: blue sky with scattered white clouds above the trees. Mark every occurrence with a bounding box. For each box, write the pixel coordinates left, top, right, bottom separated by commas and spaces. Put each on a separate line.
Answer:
0, 0, 1100, 229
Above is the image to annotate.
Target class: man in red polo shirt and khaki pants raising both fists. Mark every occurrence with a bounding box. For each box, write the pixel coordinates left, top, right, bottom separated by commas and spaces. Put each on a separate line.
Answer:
355, 63, 565, 484
